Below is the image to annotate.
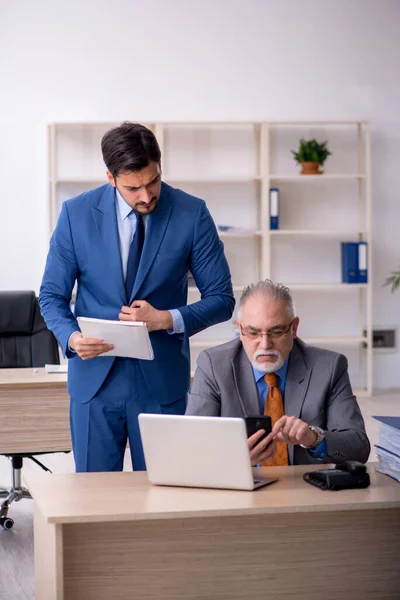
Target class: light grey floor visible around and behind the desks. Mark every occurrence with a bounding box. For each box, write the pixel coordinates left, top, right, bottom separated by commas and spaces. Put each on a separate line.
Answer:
0, 390, 400, 600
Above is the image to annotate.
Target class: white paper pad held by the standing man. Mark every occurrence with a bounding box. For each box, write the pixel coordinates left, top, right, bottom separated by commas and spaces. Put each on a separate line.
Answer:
77, 317, 154, 360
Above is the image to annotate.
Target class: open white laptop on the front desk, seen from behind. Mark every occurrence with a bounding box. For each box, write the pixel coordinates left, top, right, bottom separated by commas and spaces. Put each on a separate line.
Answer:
139, 413, 276, 490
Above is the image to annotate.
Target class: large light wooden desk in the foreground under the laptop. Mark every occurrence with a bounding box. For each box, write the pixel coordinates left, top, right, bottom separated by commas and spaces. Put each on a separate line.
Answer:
28, 465, 400, 600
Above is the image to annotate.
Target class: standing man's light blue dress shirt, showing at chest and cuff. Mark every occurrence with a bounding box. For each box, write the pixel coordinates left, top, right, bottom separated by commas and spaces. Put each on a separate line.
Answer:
116, 189, 185, 333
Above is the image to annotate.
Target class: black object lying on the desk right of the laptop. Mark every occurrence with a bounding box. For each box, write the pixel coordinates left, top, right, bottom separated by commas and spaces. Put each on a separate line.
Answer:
303, 460, 371, 490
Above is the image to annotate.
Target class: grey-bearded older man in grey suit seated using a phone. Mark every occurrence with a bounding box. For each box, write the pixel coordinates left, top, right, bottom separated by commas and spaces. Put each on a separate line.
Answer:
186, 279, 370, 465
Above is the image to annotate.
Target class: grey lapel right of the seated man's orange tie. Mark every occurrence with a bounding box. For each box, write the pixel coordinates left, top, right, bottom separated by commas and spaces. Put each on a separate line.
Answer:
284, 341, 312, 465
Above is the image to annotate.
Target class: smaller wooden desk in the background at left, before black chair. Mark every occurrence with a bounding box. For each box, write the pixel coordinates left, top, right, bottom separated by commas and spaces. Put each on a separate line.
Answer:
0, 368, 71, 454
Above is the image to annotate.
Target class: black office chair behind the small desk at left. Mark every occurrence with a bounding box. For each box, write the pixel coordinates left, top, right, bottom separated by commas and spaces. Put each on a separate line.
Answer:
0, 291, 60, 529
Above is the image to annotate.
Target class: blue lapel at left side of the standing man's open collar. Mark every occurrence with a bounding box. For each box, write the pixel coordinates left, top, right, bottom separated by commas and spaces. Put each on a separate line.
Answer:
92, 185, 127, 304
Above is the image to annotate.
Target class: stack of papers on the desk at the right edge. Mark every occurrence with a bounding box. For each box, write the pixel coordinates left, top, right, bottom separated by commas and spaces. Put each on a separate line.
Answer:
374, 417, 400, 481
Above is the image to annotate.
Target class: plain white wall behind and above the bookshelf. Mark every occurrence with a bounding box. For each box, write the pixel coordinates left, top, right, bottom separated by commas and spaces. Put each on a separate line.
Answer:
0, 0, 400, 388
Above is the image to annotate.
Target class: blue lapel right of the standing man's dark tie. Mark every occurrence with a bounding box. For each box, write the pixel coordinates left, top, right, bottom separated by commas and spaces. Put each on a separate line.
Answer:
129, 184, 172, 304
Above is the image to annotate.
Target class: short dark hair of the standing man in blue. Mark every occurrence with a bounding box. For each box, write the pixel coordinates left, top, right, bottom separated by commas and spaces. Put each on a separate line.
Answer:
101, 121, 161, 177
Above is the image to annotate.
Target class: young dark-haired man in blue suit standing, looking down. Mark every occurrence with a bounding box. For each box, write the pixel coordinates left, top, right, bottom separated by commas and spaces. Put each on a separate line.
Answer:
39, 123, 235, 471
